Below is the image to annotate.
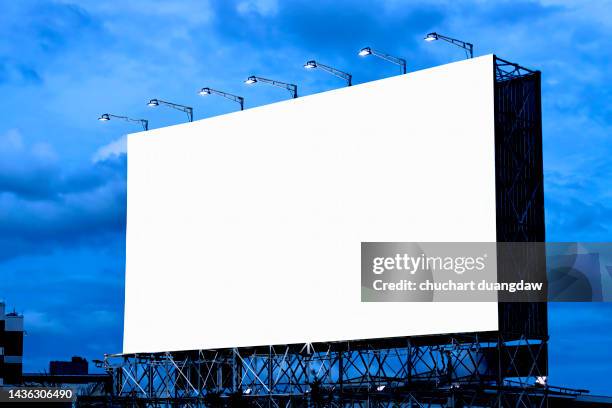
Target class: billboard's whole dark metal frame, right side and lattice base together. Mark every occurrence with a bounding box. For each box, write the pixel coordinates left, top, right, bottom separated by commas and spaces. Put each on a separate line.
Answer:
101, 57, 564, 407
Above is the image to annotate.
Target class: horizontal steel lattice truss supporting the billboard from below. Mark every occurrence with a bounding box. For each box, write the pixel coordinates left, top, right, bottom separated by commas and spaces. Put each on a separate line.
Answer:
98, 332, 546, 407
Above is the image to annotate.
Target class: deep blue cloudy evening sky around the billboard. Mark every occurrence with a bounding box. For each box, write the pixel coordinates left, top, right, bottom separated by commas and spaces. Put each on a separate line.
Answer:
0, 0, 612, 394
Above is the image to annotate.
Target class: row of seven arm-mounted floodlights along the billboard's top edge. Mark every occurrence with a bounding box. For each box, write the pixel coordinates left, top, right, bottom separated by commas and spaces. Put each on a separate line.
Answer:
98, 33, 474, 130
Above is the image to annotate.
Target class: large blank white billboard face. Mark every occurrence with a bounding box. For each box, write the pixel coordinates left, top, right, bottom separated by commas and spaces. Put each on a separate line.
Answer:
123, 56, 498, 353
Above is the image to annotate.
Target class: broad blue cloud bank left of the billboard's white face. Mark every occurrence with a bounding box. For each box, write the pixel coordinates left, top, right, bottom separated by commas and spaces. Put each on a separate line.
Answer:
0, 130, 126, 260
